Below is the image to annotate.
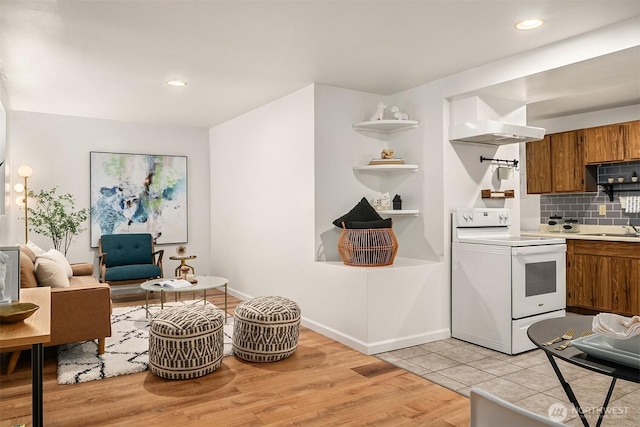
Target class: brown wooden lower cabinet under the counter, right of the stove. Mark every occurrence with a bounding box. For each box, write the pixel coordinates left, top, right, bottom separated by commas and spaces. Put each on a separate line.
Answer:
567, 239, 640, 316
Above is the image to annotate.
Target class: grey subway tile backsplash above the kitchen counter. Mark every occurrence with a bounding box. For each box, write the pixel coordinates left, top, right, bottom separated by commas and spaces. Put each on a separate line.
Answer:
540, 161, 640, 225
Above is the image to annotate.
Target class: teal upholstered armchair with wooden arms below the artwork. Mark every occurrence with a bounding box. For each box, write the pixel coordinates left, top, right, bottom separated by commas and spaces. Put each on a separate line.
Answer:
98, 233, 164, 285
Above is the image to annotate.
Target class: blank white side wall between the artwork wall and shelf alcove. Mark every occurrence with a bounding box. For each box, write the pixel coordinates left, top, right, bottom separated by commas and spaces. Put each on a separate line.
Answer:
209, 86, 314, 304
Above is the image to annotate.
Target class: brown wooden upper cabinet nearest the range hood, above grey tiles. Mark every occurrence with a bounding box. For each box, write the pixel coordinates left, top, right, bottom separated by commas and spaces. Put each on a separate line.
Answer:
526, 131, 597, 194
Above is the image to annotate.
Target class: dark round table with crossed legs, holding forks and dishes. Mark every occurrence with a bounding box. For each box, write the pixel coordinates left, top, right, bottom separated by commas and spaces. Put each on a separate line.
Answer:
527, 315, 640, 427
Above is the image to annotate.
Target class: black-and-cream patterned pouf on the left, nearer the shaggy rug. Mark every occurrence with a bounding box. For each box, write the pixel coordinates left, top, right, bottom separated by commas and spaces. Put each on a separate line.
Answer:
149, 304, 224, 380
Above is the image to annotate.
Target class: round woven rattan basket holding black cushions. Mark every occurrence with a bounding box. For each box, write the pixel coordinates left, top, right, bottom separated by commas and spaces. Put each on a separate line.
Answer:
338, 227, 398, 267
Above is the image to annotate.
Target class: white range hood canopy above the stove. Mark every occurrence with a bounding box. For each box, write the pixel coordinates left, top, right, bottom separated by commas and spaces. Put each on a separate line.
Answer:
449, 120, 546, 145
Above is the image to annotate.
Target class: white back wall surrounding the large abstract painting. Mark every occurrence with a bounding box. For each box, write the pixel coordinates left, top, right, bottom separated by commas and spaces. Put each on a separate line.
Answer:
1, 111, 211, 274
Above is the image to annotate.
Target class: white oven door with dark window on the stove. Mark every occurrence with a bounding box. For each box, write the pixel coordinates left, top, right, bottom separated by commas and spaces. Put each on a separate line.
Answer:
511, 244, 567, 319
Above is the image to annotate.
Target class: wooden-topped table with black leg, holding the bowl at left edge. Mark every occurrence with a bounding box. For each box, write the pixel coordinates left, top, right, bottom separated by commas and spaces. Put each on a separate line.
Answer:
0, 287, 51, 426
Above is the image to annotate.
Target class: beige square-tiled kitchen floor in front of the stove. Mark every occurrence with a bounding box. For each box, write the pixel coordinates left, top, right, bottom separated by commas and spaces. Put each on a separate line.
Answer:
376, 338, 640, 427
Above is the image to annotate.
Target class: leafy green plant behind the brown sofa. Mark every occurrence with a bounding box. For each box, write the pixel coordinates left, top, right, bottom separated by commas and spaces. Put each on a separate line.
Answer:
28, 187, 89, 256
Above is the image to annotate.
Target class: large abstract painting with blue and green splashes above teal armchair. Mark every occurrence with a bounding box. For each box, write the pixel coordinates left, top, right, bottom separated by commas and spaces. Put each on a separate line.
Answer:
90, 151, 188, 248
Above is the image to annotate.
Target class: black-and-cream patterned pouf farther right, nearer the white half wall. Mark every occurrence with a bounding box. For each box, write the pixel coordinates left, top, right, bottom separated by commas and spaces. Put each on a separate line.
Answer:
233, 296, 300, 362
